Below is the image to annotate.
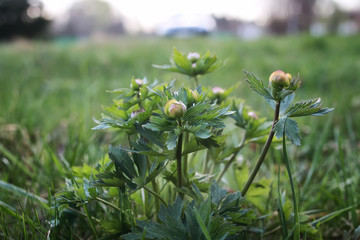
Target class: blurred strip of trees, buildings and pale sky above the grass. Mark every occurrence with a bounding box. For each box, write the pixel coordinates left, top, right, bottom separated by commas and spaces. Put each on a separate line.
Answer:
0, 0, 360, 40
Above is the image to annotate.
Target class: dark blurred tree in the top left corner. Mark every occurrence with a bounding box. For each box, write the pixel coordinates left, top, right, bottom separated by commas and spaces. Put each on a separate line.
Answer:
0, 0, 49, 40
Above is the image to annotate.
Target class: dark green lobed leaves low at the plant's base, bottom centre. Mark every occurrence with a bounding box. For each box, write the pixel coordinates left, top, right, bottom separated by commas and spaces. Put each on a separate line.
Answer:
122, 184, 255, 240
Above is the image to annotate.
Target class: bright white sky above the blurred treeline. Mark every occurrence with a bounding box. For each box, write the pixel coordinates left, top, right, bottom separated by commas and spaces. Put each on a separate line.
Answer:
42, 0, 360, 31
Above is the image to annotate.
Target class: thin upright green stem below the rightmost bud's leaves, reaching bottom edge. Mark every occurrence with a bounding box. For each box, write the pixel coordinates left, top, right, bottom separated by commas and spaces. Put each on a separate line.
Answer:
283, 132, 300, 240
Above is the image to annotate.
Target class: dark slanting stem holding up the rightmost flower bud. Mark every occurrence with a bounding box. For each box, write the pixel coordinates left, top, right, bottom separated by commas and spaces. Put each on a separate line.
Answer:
241, 102, 280, 196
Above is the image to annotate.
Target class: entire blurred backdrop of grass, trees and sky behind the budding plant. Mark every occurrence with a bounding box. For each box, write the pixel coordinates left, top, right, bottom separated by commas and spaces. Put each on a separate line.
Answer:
0, 0, 360, 239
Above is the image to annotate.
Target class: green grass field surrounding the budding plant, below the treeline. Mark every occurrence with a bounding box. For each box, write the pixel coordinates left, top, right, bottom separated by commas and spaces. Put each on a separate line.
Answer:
0, 36, 360, 239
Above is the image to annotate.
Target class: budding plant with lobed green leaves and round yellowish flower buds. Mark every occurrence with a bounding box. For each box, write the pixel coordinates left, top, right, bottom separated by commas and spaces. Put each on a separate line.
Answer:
45, 49, 338, 240
